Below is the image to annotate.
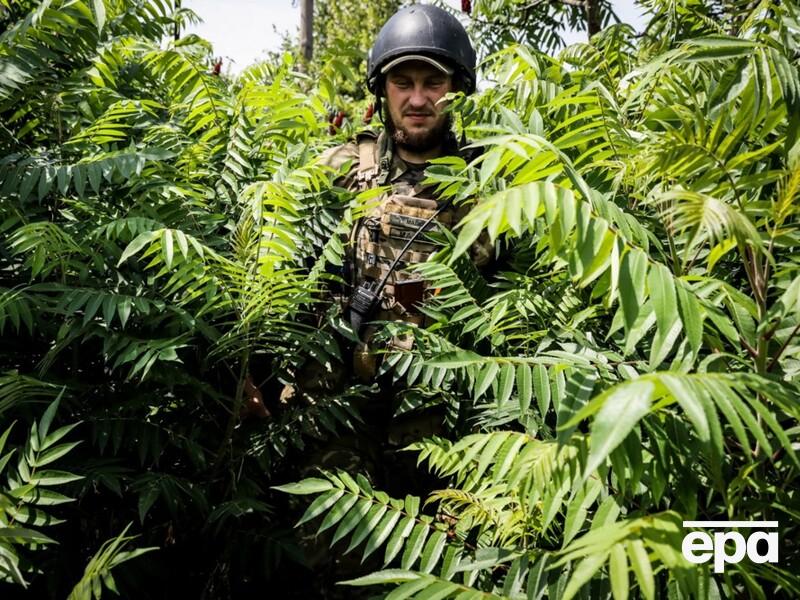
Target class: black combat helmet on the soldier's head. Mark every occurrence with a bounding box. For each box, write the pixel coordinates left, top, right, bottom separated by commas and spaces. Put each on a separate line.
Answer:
367, 4, 475, 95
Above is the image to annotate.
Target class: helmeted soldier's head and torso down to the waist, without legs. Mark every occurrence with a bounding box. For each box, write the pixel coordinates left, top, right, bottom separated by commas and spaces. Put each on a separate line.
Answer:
322, 4, 490, 381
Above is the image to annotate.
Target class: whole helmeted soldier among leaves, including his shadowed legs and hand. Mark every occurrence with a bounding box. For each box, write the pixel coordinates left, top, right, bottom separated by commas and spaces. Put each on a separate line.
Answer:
281, 4, 491, 483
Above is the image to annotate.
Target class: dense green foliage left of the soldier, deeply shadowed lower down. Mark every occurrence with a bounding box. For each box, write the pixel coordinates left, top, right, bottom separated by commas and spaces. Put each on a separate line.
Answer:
0, 0, 366, 597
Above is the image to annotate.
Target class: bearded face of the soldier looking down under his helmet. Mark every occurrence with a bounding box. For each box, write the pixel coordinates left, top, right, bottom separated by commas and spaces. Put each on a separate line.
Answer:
386, 60, 453, 152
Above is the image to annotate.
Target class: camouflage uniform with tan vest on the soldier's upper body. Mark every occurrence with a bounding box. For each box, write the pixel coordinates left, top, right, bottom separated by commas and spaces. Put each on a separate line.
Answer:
321, 131, 492, 381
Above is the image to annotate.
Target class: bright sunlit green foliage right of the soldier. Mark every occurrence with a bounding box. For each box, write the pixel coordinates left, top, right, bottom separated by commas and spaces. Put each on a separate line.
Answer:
283, 2, 800, 599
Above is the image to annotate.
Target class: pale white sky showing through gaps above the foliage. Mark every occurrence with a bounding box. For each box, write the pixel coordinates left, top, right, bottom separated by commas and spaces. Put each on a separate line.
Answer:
183, 0, 645, 73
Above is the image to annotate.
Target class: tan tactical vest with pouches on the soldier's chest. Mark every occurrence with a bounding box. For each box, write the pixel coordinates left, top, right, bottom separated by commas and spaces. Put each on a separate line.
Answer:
350, 135, 457, 324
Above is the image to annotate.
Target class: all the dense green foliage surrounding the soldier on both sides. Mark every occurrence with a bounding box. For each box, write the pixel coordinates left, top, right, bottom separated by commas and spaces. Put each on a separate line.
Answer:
0, 0, 800, 600
